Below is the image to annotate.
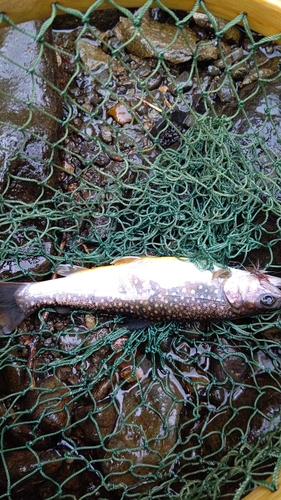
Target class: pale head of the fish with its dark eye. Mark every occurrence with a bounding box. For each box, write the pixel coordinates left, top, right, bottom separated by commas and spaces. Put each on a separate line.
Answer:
223, 269, 281, 316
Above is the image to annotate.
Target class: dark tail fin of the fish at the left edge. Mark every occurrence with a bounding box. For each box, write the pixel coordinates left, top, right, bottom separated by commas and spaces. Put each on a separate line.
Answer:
0, 283, 30, 334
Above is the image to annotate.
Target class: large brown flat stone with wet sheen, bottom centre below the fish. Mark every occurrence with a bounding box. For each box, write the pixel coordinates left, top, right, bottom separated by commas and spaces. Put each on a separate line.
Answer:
102, 380, 182, 491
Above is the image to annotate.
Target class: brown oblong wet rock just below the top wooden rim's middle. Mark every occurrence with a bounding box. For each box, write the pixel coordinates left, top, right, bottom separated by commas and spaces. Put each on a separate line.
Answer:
114, 17, 198, 64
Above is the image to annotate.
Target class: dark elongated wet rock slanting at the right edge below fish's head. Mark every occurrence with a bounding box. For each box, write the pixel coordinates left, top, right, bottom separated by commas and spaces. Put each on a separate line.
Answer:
200, 373, 281, 460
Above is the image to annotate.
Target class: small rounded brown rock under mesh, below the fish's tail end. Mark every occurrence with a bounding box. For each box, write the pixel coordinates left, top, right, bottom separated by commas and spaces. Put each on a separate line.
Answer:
25, 376, 71, 432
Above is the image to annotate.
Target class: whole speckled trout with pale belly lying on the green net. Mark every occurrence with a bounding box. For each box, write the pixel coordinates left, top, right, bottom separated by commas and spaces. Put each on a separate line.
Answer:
0, 256, 281, 334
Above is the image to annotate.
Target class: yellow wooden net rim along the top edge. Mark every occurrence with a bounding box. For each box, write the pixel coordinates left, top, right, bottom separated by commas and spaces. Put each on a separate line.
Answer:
0, 0, 281, 36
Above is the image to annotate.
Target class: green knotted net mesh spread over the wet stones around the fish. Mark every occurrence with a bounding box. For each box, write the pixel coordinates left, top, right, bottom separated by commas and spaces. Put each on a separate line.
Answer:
0, 0, 281, 500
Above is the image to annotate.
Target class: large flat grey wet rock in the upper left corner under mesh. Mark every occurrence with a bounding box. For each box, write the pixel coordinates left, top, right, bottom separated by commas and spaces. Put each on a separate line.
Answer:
0, 22, 61, 199
